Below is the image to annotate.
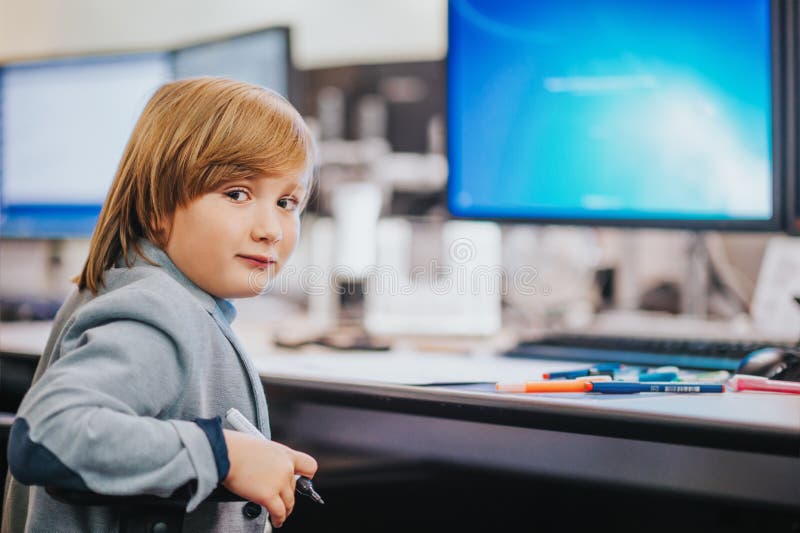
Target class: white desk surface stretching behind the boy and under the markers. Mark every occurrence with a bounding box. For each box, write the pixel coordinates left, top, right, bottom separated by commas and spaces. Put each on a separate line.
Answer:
6, 322, 800, 434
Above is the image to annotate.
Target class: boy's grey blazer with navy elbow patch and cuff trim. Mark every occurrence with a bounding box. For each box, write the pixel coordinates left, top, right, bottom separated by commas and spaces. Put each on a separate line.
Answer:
2, 241, 269, 533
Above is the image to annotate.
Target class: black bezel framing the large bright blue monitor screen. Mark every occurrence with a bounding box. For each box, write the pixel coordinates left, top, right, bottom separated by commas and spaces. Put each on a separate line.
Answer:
446, 0, 800, 232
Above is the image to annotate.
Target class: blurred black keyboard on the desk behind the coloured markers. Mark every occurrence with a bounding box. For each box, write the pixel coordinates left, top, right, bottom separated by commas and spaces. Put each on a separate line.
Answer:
504, 334, 796, 371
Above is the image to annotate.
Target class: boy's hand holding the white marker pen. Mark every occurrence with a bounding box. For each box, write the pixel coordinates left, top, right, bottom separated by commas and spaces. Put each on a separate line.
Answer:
223, 429, 317, 527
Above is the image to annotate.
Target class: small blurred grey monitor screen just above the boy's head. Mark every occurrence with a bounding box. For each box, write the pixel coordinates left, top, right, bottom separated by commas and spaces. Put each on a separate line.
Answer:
175, 28, 290, 98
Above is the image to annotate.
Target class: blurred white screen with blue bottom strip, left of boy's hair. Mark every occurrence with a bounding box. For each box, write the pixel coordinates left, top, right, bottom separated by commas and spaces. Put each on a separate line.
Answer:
0, 54, 172, 238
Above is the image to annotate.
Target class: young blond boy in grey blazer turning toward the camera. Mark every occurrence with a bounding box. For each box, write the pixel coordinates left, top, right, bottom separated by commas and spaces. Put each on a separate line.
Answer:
2, 78, 317, 533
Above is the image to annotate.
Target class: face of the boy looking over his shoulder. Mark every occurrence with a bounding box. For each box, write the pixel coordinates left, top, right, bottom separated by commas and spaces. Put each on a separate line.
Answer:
165, 174, 306, 298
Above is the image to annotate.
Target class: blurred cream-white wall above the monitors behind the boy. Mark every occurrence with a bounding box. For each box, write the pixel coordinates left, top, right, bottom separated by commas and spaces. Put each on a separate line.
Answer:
0, 0, 447, 69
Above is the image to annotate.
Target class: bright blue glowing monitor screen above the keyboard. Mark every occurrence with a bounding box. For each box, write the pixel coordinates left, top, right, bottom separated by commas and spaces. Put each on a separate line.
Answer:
448, 0, 780, 229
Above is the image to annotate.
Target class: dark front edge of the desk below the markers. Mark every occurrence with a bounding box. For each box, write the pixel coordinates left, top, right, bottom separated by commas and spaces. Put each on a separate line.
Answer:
261, 376, 800, 458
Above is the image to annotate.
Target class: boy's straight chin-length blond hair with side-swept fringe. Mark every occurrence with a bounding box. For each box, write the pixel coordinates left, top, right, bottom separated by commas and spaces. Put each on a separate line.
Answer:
75, 77, 315, 294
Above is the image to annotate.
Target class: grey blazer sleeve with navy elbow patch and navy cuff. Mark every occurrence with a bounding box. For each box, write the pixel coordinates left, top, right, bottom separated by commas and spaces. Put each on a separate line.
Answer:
8, 290, 229, 511
